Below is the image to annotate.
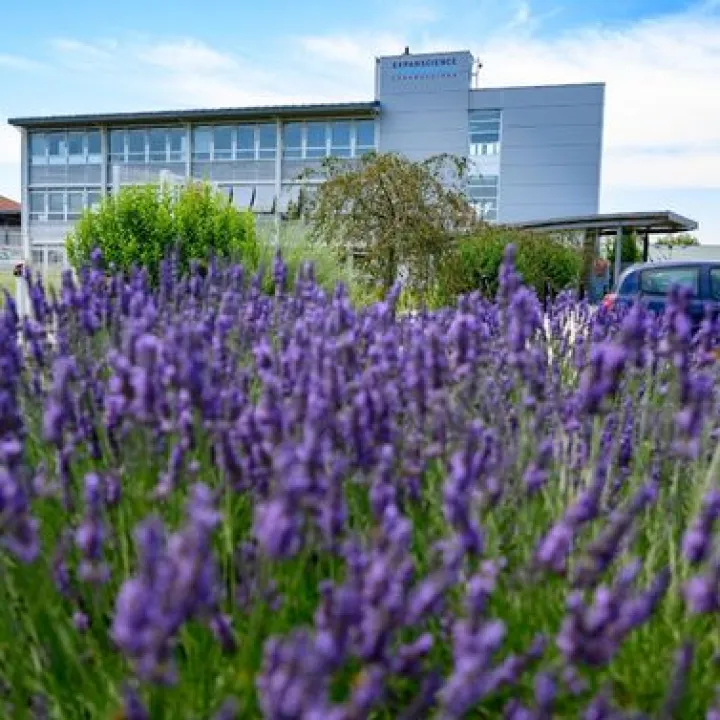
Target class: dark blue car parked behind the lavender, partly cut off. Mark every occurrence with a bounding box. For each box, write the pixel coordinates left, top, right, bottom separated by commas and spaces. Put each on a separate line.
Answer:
603, 260, 720, 327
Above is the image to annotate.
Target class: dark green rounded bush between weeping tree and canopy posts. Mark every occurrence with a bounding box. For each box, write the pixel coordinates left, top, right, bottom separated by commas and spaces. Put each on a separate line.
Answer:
434, 226, 582, 305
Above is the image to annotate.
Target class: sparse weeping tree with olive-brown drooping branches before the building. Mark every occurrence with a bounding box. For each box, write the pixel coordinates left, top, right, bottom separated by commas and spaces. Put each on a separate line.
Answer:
307, 153, 478, 291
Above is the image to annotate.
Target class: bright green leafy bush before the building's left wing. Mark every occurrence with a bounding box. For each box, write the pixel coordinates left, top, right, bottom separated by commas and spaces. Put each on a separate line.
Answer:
67, 183, 258, 279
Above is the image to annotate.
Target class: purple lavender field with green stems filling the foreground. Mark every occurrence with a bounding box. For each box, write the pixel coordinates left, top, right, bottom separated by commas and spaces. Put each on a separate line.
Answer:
0, 245, 720, 720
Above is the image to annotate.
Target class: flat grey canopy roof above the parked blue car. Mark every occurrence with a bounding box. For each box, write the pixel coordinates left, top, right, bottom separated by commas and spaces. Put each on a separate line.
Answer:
512, 210, 698, 235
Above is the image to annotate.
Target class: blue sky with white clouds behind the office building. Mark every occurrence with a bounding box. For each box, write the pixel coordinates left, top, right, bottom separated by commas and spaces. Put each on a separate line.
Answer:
0, 0, 720, 244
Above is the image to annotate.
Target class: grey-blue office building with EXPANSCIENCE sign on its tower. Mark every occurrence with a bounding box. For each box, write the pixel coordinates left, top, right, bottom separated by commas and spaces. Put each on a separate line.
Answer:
10, 51, 604, 262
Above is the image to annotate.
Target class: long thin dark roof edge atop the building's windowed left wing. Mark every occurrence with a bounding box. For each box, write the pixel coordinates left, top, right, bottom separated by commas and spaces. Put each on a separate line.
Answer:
8, 100, 380, 129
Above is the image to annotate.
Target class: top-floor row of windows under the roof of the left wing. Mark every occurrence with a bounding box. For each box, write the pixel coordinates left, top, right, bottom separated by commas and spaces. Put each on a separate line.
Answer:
30, 120, 375, 165
